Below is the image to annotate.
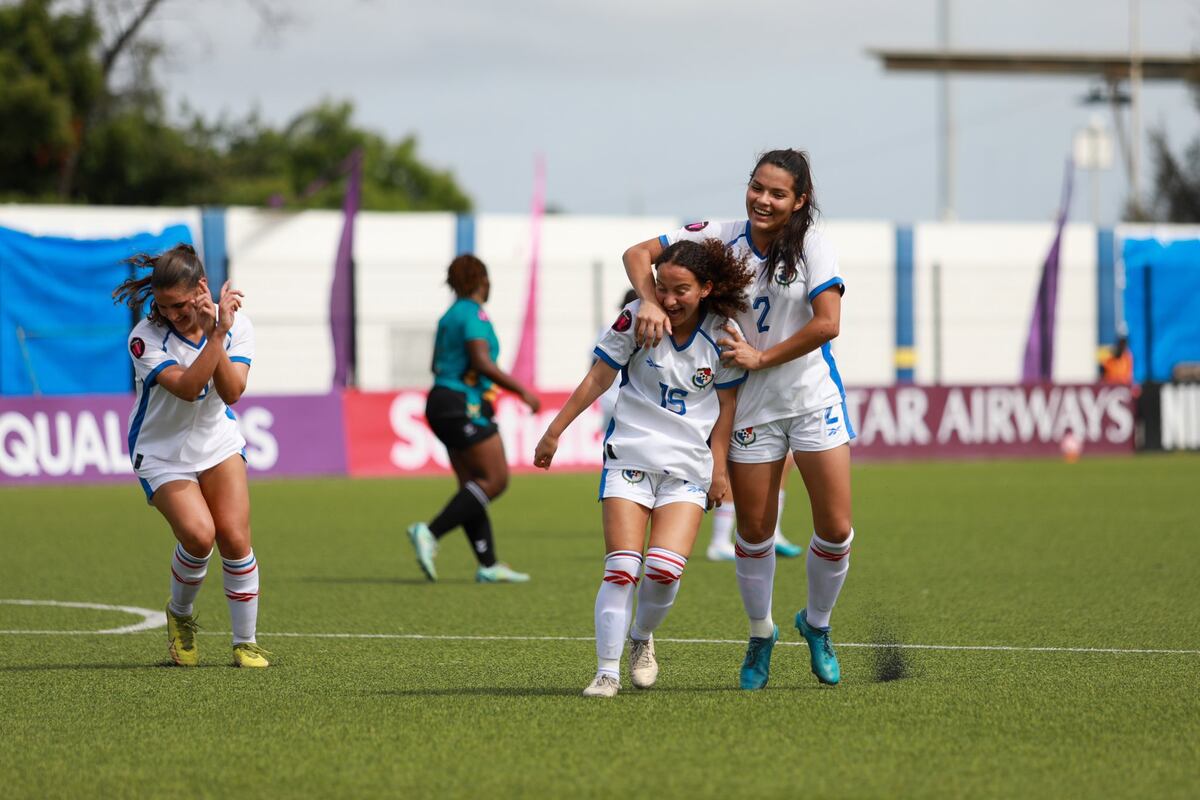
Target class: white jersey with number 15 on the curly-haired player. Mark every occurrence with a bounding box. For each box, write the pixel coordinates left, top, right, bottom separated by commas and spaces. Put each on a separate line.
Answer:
595, 300, 746, 491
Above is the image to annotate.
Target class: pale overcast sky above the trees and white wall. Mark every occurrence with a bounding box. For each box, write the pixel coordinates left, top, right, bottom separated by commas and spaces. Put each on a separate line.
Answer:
142, 0, 1200, 222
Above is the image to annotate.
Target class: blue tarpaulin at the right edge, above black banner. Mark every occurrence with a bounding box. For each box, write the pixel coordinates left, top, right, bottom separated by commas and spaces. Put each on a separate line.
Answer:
1122, 239, 1200, 383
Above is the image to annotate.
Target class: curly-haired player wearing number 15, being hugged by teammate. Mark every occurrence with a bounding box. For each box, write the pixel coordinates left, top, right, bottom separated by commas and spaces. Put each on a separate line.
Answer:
534, 241, 751, 697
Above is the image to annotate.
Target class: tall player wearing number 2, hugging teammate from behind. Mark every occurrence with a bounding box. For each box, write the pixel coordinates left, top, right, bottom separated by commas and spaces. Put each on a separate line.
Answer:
624, 150, 854, 690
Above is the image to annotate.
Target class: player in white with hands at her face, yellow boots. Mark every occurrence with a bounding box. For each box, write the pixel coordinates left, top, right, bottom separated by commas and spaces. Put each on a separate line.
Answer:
113, 245, 270, 667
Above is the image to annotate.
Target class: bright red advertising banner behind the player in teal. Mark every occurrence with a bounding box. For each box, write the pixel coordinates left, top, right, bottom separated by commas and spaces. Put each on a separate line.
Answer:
343, 390, 604, 475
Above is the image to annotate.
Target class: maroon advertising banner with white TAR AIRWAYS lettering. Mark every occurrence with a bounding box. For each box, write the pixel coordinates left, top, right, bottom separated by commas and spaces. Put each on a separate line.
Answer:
846, 384, 1134, 458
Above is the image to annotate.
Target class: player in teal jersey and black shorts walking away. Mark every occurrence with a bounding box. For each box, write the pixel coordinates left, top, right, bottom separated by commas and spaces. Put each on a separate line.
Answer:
408, 255, 540, 583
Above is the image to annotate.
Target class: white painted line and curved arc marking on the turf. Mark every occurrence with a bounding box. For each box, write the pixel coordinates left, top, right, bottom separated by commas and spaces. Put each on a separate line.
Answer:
0, 600, 1200, 656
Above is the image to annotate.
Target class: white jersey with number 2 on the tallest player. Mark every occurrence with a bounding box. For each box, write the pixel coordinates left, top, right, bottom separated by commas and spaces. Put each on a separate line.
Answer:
659, 219, 846, 429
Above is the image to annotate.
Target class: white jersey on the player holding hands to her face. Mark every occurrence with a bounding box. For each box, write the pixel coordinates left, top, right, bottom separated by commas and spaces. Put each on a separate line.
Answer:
128, 313, 254, 471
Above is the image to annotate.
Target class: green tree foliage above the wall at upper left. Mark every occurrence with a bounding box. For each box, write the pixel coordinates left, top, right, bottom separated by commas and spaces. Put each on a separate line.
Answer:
0, 0, 470, 211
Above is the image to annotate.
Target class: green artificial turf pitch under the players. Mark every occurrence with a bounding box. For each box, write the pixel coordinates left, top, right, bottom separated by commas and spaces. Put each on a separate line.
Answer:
0, 457, 1200, 798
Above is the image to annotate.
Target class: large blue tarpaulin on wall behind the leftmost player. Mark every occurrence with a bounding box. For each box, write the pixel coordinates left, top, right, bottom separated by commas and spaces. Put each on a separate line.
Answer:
0, 225, 192, 395
